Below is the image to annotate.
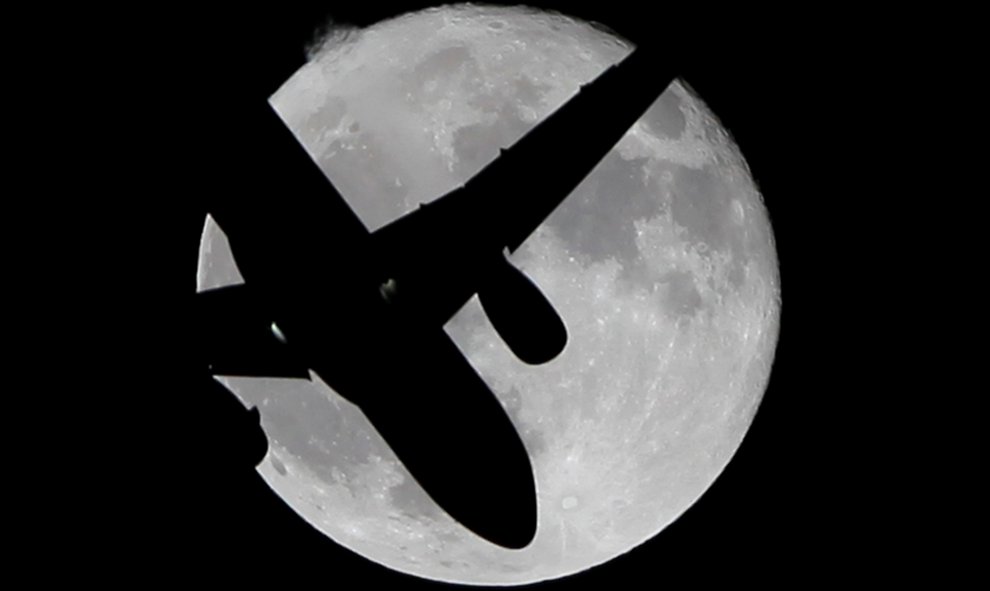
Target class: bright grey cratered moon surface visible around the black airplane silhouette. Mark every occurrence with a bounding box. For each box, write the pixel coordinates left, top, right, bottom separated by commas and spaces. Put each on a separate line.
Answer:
199, 6, 780, 585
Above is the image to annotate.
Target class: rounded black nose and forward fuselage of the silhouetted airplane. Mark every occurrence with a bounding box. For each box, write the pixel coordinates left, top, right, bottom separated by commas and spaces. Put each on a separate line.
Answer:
359, 331, 537, 549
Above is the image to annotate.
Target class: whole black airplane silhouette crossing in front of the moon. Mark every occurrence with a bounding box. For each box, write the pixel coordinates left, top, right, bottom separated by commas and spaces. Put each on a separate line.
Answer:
197, 40, 674, 549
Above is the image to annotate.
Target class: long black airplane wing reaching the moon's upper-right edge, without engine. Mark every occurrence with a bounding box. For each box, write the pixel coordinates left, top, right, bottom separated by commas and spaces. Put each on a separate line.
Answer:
374, 46, 674, 260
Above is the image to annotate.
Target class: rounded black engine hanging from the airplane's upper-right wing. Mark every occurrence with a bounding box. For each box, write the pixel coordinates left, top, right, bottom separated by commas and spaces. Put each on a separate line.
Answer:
478, 257, 567, 365
